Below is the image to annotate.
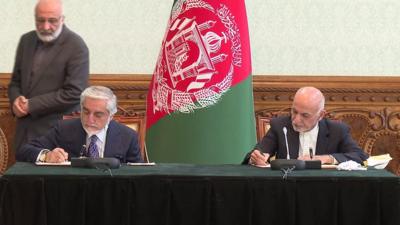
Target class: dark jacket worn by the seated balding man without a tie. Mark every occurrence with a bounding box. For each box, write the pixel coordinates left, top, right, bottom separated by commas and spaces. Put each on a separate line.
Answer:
243, 116, 368, 164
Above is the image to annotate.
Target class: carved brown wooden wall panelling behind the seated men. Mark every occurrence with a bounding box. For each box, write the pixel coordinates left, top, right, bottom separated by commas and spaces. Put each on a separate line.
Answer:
0, 74, 400, 174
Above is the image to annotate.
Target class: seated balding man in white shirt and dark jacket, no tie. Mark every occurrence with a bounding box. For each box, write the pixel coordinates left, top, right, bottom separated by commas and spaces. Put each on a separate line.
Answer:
243, 87, 368, 166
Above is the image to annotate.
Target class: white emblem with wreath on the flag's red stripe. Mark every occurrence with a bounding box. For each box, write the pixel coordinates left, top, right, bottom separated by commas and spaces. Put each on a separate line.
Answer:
151, 0, 243, 114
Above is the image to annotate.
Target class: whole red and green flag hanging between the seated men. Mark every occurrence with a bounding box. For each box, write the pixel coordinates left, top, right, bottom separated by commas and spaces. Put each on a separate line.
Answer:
146, 0, 256, 164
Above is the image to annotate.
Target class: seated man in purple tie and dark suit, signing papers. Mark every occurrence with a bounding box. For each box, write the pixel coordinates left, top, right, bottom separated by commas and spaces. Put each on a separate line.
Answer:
16, 86, 143, 163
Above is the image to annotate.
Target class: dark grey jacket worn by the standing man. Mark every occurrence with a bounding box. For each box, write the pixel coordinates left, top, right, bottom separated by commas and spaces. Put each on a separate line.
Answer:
8, 26, 89, 150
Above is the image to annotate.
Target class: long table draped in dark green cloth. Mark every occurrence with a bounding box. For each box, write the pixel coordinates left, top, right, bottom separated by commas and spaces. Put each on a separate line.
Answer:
0, 162, 400, 225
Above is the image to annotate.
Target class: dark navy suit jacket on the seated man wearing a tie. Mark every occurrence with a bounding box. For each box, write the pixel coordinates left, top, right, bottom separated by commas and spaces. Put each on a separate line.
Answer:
16, 119, 143, 162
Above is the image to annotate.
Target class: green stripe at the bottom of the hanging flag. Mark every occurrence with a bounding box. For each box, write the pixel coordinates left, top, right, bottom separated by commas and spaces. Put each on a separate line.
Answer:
146, 76, 256, 164
